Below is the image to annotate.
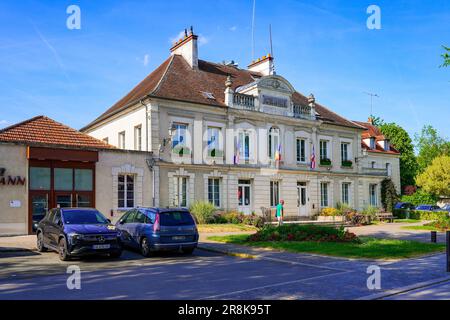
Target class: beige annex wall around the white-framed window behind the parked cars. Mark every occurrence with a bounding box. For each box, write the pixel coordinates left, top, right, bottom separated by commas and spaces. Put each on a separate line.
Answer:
95, 150, 152, 221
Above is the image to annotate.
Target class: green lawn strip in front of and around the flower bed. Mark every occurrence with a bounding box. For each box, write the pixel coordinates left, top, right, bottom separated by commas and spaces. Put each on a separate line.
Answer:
208, 235, 445, 259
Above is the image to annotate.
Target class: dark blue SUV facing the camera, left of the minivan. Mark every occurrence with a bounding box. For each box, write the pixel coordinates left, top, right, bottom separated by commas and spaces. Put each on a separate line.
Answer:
36, 208, 122, 261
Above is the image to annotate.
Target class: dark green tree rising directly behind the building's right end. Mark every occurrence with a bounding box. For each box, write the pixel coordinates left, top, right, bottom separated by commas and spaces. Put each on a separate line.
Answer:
380, 123, 417, 190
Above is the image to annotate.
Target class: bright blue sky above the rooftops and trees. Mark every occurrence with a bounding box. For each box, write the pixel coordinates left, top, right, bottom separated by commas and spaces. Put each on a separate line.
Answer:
0, 0, 450, 137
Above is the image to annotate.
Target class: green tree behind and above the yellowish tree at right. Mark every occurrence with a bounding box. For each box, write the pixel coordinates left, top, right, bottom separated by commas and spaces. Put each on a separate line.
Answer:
415, 125, 450, 173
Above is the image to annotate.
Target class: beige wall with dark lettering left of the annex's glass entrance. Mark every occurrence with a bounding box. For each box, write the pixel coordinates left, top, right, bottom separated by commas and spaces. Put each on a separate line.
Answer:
0, 143, 28, 235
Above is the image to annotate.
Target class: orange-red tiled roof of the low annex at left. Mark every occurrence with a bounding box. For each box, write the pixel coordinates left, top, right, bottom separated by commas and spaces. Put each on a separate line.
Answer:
0, 116, 115, 149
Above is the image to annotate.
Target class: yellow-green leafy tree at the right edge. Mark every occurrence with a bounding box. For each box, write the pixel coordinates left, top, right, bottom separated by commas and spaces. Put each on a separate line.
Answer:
416, 156, 450, 197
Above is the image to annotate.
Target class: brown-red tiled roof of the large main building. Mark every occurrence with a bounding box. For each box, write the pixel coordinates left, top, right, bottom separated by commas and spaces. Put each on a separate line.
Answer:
81, 55, 362, 131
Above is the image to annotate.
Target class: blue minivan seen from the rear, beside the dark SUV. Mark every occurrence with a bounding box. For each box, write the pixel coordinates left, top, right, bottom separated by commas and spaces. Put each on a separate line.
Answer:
116, 208, 198, 257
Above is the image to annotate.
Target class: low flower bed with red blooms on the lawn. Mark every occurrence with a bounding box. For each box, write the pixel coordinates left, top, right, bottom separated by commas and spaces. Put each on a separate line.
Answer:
249, 224, 360, 243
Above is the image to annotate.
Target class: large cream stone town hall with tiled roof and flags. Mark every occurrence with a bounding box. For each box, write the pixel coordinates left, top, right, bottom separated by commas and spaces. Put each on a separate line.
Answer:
81, 31, 400, 217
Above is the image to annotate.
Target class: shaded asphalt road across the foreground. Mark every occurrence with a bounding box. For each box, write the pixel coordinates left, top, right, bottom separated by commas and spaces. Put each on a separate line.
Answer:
0, 250, 446, 300
